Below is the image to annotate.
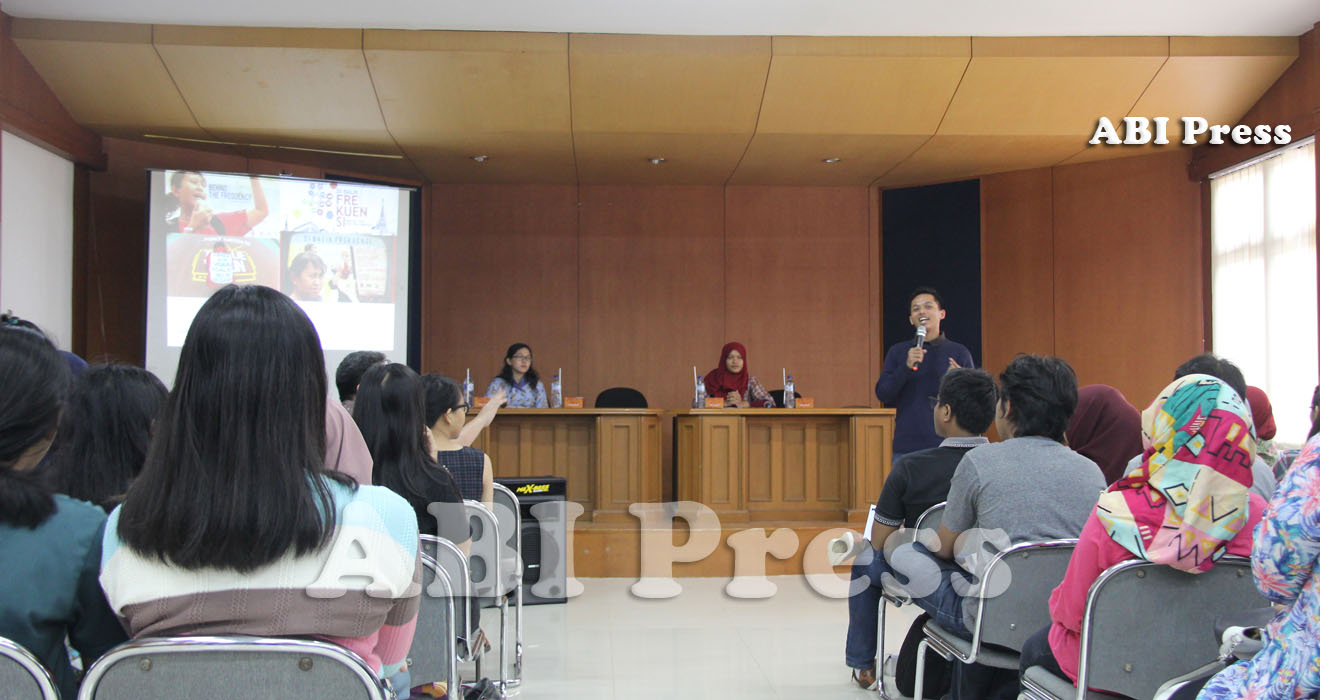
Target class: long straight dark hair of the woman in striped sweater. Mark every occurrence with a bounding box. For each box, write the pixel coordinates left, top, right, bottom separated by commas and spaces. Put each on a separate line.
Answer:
119, 284, 355, 572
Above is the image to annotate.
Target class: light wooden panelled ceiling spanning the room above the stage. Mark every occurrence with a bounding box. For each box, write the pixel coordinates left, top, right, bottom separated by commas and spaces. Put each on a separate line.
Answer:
13, 20, 1298, 186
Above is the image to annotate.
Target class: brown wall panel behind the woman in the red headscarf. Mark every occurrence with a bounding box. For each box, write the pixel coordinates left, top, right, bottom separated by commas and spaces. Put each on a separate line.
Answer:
723, 186, 876, 407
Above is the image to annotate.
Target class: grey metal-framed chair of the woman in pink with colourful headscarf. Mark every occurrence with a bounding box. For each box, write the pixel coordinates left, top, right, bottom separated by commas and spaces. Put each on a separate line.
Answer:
1022, 556, 1266, 700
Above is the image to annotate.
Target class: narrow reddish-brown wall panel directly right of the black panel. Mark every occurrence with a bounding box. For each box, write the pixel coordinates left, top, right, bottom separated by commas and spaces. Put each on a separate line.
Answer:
981, 168, 1055, 374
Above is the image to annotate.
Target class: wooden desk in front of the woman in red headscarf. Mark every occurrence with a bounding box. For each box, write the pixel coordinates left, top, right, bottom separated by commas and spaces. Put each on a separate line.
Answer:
673, 408, 894, 522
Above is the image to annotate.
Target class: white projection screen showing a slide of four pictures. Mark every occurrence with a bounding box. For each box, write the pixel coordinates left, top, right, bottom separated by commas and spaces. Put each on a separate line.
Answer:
148, 170, 412, 361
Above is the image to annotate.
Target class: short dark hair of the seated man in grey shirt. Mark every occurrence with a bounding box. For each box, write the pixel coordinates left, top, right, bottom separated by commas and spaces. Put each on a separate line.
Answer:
999, 355, 1077, 442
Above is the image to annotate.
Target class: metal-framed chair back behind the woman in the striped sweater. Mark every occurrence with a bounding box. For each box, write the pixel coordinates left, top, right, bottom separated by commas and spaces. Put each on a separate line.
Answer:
78, 637, 395, 700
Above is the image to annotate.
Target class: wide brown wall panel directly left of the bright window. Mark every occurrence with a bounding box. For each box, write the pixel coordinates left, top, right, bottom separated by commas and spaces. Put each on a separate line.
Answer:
1050, 152, 1204, 405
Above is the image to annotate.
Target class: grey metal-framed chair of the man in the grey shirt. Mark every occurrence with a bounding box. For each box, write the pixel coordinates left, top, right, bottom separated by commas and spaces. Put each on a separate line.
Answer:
912, 539, 1077, 697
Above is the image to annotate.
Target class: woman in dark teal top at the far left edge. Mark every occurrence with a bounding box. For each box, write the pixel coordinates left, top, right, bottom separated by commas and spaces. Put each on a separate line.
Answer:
0, 324, 127, 697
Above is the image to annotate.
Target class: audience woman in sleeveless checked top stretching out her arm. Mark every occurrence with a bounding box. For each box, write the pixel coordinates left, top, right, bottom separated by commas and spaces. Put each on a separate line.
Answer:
421, 374, 498, 507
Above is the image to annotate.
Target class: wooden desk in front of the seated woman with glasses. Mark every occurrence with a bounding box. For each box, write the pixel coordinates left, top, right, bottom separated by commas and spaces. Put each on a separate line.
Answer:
473, 408, 664, 522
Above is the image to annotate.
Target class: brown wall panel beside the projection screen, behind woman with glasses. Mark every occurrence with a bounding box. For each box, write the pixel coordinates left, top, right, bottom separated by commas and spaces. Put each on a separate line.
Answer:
421, 185, 578, 394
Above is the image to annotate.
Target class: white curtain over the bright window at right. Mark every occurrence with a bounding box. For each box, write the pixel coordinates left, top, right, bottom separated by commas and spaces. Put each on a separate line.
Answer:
1210, 141, 1317, 444
